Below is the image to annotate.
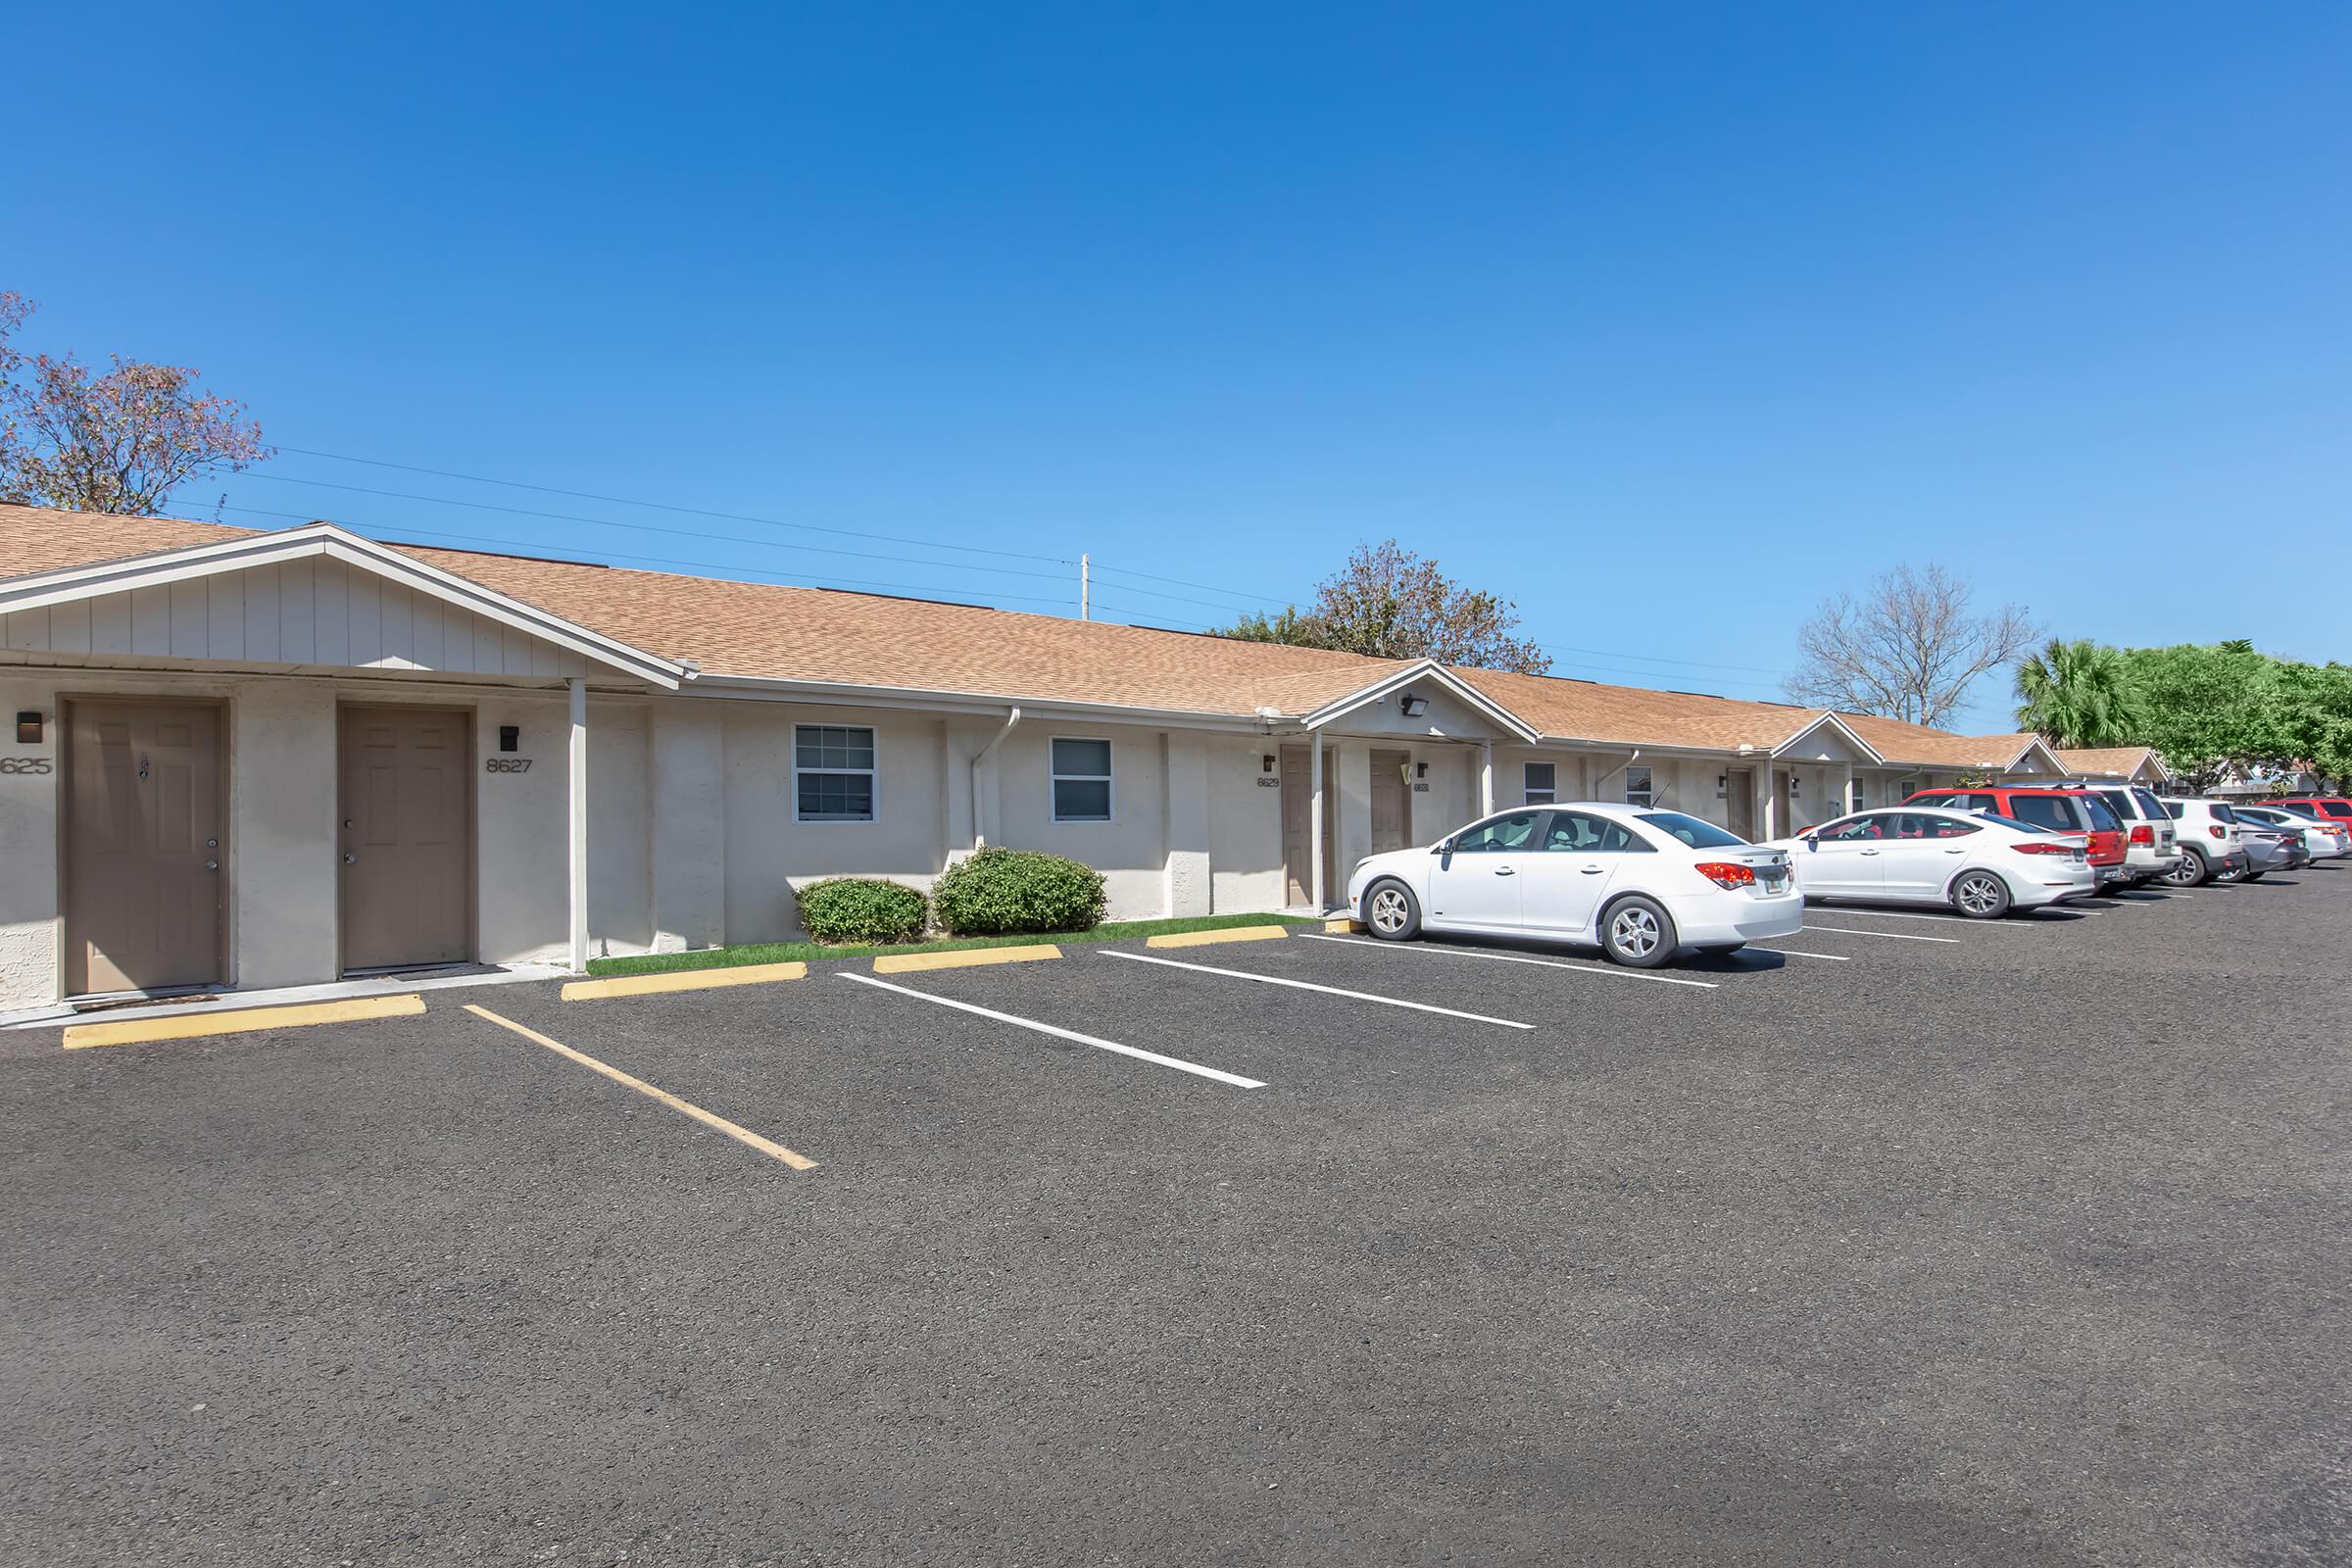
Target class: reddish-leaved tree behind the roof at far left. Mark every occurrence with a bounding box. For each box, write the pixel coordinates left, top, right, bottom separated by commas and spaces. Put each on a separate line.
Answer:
0, 294, 275, 517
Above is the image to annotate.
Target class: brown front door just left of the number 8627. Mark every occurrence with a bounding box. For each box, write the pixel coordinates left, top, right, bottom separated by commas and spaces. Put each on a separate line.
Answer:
336, 708, 472, 971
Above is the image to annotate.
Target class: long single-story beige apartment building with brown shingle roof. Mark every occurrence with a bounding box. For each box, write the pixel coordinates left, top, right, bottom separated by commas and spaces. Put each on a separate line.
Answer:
0, 506, 2063, 1008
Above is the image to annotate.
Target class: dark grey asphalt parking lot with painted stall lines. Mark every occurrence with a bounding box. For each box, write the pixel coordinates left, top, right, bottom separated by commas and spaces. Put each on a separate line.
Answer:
0, 867, 2352, 1568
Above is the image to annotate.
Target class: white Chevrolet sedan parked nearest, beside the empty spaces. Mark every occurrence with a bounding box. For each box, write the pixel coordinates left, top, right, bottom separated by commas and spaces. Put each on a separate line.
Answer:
1348, 802, 1804, 968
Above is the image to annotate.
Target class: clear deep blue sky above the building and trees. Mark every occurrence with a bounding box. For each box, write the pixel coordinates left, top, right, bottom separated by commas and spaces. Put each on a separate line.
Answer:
0, 2, 2352, 726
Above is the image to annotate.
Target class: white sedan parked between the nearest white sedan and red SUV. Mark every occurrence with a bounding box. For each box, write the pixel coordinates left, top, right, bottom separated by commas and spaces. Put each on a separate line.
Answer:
1774, 807, 2098, 919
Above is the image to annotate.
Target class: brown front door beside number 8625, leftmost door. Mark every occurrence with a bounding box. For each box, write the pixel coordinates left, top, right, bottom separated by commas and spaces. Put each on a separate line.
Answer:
66, 703, 228, 997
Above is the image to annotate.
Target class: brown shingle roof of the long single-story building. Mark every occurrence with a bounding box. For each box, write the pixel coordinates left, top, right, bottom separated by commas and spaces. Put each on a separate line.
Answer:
0, 506, 2033, 766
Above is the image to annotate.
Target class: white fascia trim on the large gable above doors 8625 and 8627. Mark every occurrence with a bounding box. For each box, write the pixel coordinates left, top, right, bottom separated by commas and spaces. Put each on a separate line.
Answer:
0, 522, 689, 691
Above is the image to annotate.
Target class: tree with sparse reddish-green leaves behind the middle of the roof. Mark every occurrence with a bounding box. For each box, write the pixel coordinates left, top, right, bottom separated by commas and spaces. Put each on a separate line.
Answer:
1225, 538, 1552, 674
